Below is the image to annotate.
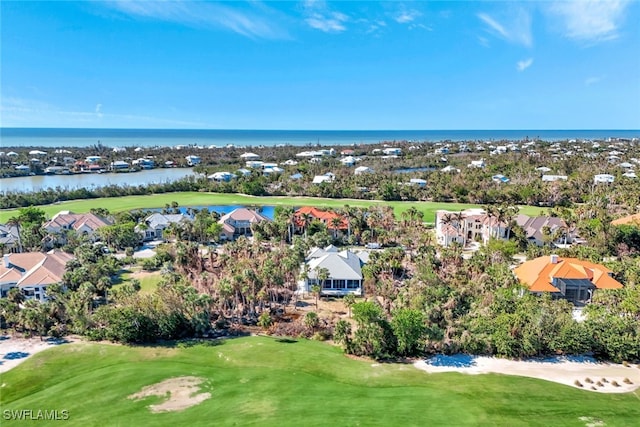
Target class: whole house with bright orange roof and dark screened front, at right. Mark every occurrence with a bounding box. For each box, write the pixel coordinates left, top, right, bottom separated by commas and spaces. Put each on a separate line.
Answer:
514, 255, 623, 304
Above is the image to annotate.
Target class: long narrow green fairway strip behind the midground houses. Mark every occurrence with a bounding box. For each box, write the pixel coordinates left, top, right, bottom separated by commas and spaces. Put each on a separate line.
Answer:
0, 192, 542, 223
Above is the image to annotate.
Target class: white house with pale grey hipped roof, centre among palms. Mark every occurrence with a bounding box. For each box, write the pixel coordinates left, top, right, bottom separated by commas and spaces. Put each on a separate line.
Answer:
298, 246, 368, 295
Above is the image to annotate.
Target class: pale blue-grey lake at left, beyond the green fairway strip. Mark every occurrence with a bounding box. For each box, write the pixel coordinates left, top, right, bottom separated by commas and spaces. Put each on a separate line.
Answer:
0, 168, 196, 193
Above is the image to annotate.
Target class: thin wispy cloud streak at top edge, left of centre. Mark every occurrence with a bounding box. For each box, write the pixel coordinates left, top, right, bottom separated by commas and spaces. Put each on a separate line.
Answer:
103, 0, 288, 39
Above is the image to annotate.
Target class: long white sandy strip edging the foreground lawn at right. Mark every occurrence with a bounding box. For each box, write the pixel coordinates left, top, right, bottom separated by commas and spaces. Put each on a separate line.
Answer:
414, 356, 640, 393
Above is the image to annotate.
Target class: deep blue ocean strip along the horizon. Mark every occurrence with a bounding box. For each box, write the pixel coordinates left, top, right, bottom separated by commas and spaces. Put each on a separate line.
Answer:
0, 128, 640, 148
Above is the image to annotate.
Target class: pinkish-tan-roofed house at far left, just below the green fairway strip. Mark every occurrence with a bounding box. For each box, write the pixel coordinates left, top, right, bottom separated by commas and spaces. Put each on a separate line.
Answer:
42, 211, 113, 248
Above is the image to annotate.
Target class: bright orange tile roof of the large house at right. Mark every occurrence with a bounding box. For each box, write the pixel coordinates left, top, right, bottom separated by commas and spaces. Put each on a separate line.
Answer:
514, 256, 622, 292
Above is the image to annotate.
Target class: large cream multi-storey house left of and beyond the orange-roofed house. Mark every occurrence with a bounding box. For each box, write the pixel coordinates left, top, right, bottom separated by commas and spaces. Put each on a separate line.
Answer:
436, 208, 510, 246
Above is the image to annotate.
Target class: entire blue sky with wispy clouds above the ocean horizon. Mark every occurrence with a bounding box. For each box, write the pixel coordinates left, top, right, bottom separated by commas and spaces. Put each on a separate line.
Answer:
0, 0, 640, 130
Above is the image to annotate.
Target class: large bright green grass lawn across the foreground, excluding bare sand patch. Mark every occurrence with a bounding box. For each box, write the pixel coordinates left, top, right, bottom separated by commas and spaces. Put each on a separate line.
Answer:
0, 337, 640, 427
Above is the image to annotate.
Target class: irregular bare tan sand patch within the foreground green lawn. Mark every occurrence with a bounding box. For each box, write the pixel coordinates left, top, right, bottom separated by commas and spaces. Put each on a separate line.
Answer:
129, 377, 211, 412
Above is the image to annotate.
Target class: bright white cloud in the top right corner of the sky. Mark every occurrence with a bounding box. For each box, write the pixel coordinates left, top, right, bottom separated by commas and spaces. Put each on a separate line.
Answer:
549, 0, 629, 42
